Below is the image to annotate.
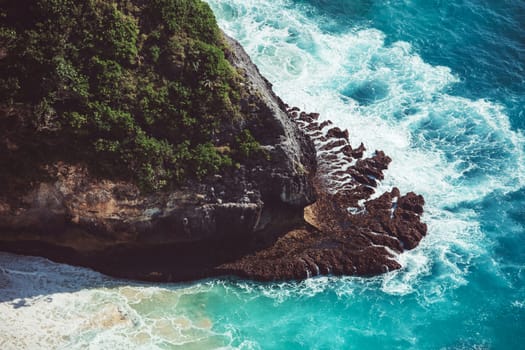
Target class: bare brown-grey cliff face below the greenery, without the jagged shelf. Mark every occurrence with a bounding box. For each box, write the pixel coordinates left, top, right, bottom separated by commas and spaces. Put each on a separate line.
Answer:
0, 31, 316, 280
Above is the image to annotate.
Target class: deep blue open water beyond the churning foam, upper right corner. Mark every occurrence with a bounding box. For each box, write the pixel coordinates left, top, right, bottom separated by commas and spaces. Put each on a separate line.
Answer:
294, 0, 525, 129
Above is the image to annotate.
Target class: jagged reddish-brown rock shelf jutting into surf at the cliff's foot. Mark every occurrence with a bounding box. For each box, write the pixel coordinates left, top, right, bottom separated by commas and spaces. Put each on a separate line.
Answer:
217, 108, 427, 280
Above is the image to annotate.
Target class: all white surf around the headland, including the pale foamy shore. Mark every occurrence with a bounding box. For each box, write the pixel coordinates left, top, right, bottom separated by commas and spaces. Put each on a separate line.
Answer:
0, 7, 525, 349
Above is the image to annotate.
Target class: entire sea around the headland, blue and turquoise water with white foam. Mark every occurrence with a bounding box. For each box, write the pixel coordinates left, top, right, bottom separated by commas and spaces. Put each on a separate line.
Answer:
0, 0, 525, 349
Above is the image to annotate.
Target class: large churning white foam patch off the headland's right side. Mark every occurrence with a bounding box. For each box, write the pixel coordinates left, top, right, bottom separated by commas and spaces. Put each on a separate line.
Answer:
208, 0, 525, 300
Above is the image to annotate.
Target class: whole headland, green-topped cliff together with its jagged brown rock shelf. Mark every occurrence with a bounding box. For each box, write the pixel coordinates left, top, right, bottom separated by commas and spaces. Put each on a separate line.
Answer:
0, 0, 426, 281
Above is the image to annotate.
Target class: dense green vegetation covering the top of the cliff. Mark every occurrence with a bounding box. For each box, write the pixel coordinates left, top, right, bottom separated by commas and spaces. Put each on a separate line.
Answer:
0, 0, 259, 190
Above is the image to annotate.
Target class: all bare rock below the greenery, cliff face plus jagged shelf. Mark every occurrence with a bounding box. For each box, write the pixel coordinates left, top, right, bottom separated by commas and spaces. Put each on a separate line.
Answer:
0, 33, 426, 281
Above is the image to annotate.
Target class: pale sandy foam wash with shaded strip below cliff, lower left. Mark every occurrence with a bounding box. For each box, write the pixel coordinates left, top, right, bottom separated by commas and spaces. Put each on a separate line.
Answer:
0, 253, 235, 349
